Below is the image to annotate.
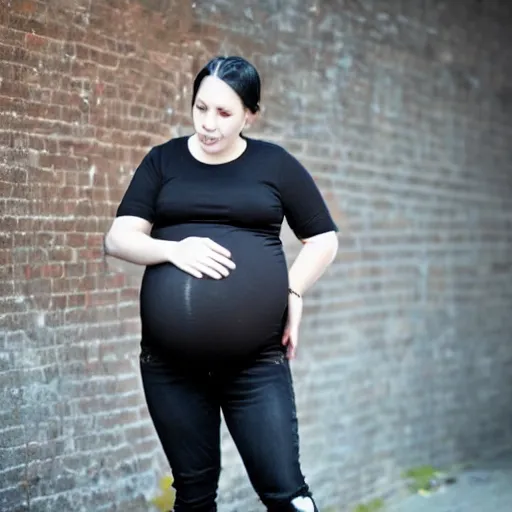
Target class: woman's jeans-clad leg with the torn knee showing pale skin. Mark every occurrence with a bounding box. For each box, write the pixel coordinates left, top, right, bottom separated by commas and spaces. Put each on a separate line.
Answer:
221, 354, 317, 512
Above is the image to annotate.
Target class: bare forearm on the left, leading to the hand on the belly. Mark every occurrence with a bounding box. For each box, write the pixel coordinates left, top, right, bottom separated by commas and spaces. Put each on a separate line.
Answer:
105, 231, 177, 265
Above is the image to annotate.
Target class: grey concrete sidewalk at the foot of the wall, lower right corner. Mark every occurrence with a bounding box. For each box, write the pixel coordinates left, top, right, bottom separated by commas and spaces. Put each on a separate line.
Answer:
386, 451, 512, 512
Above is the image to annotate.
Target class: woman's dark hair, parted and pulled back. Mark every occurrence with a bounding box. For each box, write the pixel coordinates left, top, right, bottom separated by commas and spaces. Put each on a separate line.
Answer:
192, 56, 261, 114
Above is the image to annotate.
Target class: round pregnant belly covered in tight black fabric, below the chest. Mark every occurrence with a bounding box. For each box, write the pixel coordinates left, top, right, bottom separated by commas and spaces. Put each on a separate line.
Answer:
141, 225, 288, 360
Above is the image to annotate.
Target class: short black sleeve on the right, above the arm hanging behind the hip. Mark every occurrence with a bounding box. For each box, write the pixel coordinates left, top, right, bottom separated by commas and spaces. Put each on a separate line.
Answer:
280, 150, 338, 239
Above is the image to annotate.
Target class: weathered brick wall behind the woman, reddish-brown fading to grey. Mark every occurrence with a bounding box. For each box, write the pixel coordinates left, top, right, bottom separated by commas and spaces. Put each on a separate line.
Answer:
0, 0, 512, 512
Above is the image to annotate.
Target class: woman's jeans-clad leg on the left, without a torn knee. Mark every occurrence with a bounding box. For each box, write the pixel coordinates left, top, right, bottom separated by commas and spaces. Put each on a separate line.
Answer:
140, 348, 220, 512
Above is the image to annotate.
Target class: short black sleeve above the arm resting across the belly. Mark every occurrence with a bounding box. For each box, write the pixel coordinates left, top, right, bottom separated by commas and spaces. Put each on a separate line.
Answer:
116, 148, 162, 223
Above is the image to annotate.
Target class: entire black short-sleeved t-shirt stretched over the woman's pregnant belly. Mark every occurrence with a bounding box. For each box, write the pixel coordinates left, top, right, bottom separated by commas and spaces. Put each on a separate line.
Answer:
117, 137, 336, 365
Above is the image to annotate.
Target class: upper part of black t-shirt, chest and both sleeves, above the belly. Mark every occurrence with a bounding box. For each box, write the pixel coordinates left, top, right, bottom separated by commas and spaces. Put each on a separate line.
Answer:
117, 137, 337, 239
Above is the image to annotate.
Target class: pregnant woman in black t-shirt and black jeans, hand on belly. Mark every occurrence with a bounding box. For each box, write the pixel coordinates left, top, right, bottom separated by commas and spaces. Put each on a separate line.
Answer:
105, 57, 338, 512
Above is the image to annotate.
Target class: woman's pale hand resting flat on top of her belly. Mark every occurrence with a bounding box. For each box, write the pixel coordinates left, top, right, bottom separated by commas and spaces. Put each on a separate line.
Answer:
169, 236, 235, 279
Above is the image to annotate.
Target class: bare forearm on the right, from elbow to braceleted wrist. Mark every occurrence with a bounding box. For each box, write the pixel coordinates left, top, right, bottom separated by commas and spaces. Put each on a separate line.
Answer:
289, 232, 338, 295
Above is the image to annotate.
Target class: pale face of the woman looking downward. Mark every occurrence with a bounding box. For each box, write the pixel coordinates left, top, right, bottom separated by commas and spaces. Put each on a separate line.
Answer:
192, 76, 250, 154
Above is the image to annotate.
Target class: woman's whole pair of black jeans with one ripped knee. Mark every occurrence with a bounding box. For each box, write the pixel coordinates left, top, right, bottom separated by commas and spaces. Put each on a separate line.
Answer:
141, 350, 316, 512
